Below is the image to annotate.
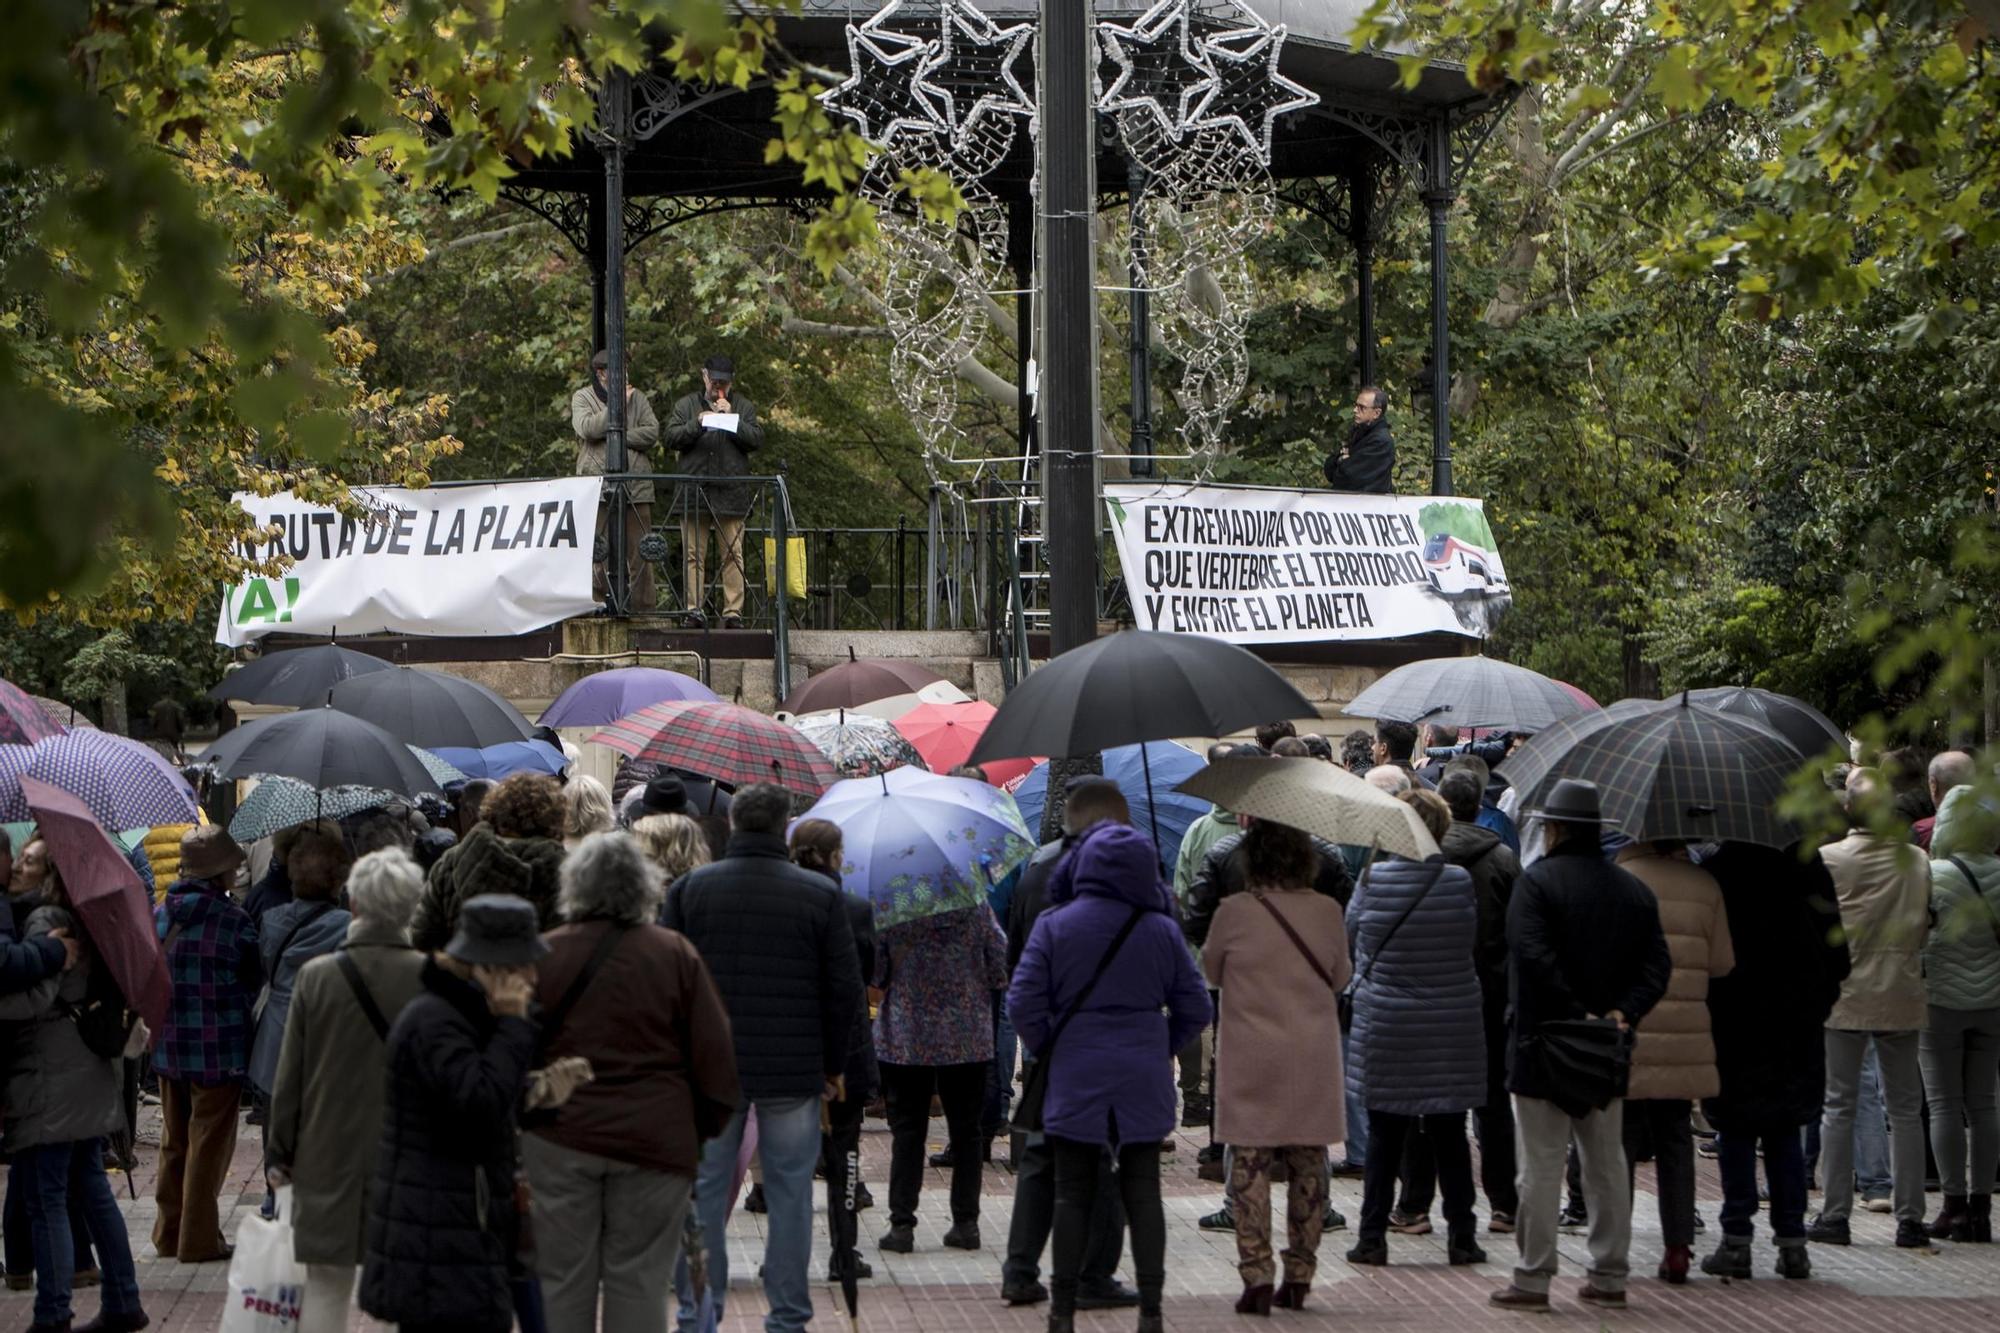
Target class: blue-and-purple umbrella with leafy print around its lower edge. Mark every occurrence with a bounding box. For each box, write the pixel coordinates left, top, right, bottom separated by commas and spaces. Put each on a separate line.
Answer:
806, 769, 1034, 929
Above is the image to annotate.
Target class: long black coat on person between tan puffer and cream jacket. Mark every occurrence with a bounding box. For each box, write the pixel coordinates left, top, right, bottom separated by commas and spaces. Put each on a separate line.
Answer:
1702, 843, 1850, 1131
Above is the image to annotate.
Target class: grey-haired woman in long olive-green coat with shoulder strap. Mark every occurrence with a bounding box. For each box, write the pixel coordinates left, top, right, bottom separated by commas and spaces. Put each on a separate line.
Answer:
264, 849, 424, 1333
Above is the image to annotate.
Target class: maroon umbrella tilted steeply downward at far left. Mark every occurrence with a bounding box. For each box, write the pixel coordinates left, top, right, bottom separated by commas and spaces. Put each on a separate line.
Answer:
20, 779, 172, 1031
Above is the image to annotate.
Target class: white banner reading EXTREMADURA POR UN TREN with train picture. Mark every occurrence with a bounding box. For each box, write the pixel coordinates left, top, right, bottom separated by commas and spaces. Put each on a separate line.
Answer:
1104, 482, 1512, 642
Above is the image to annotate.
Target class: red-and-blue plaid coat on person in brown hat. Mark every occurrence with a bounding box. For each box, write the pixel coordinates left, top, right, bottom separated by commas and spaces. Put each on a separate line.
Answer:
152, 879, 264, 1087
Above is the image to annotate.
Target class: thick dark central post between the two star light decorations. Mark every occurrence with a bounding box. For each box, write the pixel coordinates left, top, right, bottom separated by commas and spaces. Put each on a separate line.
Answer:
1036, 0, 1098, 654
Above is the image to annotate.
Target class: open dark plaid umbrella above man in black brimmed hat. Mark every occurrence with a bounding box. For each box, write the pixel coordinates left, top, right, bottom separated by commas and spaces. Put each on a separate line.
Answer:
1500, 695, 1802, 847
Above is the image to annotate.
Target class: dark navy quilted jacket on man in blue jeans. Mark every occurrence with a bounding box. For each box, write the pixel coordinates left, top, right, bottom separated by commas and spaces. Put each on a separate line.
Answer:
660, 833, 862, 1101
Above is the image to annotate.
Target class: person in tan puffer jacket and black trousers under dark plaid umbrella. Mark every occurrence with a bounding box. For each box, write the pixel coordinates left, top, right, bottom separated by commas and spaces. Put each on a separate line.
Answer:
1618, 843, 1736, 1285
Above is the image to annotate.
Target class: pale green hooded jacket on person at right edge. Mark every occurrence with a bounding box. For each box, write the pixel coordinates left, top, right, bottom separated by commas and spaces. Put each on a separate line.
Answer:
1924, 787, 2000, 1009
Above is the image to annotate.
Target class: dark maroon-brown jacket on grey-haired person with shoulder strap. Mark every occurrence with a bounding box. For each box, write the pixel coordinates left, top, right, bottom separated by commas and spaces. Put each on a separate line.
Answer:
534, 921, 742, 1175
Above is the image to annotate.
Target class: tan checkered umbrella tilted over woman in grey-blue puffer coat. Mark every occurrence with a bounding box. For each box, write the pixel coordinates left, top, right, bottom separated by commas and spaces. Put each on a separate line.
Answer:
1176, 757, 1438, 861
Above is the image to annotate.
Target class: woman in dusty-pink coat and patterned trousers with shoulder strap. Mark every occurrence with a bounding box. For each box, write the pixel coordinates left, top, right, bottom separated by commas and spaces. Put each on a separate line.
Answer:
1202, 821, 1354, 1315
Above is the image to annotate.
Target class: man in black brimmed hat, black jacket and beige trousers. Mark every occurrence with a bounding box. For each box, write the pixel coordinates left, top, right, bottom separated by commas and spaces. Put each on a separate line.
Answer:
1492, 779, 1674, 1311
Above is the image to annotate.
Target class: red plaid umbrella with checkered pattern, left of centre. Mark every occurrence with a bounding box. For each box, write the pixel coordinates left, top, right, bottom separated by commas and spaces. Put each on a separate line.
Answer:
590, 701, 840, 797
